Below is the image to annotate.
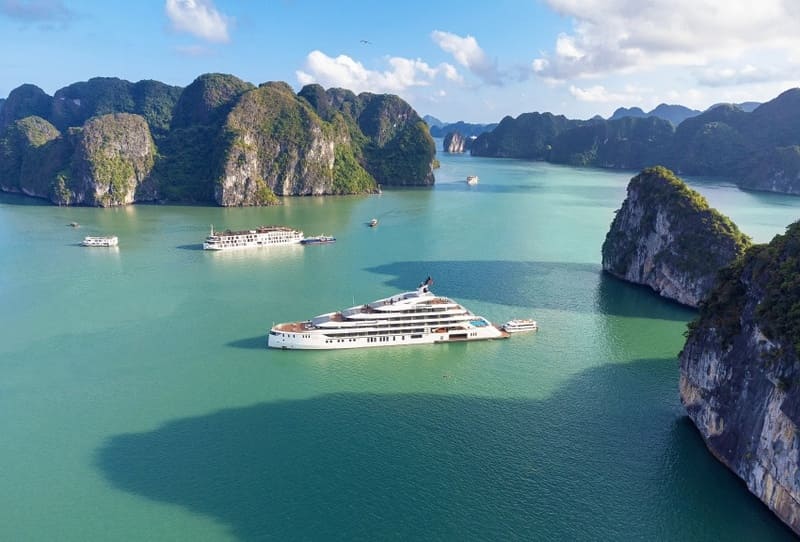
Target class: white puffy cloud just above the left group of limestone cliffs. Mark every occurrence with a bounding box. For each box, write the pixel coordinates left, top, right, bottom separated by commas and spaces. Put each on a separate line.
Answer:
295, 51, 459, 93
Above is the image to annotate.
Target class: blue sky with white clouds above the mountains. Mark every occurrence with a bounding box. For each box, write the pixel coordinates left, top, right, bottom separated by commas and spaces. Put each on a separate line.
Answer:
0, 0, 800, 123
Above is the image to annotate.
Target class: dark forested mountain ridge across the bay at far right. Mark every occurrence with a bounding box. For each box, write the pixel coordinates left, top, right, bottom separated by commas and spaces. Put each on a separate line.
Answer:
471, 88, 800, 195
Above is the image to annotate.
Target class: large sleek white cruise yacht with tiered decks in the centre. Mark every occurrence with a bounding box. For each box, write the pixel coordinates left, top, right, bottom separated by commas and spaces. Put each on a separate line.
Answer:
267, 277, 508, 350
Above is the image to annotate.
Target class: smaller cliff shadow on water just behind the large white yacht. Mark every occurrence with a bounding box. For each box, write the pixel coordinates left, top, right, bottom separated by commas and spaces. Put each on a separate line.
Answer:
367, 260, 696, 321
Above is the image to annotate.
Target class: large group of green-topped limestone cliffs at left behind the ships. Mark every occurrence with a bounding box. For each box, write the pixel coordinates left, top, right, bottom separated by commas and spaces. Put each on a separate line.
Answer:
0, 74, 436, 206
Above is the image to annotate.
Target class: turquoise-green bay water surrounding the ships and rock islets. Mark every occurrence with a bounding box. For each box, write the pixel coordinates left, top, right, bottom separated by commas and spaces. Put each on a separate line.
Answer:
0, 155, 800, 540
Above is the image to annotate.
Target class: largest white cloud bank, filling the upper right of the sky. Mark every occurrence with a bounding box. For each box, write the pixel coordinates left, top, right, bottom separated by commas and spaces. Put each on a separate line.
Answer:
531, 0, 800, 85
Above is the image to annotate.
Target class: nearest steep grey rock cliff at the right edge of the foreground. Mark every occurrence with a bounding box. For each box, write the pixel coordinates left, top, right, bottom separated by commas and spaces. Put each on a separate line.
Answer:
680, 223, 800, 535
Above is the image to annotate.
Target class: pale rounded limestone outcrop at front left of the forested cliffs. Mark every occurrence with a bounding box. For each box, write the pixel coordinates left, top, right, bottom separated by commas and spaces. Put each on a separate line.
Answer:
68, 113, 155, 207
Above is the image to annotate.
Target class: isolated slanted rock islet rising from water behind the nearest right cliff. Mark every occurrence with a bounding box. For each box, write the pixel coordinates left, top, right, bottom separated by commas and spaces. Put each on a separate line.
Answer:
602, 167, 750, 307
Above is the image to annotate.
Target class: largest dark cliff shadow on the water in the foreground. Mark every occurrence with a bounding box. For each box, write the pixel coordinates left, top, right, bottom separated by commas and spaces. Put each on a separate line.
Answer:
95, 359, 791, 541
